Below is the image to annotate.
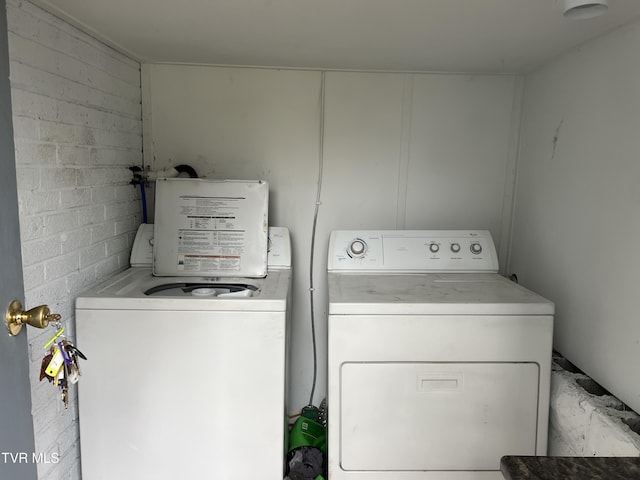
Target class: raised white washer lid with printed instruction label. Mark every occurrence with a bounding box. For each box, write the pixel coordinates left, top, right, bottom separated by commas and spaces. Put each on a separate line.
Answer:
153, 178, 269, 277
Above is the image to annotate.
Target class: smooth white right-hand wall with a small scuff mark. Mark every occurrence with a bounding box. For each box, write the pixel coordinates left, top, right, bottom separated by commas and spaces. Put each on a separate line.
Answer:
509, 23, 640, 411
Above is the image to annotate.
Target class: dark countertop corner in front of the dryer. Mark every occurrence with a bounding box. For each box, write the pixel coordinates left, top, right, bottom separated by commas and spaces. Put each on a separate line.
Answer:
500, 455, 640, 480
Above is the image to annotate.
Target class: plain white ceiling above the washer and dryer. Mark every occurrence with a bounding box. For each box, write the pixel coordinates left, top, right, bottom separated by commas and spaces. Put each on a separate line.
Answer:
32, 0, 640, 73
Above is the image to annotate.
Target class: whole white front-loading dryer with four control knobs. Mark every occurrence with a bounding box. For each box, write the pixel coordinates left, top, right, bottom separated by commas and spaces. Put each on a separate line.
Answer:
327, 231, 554, 480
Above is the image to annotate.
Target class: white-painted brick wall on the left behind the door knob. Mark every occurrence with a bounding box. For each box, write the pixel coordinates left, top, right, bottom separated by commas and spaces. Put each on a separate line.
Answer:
7, 0, 142, 480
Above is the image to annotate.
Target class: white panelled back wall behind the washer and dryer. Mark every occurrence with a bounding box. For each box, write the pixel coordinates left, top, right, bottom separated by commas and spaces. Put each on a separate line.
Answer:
143, 65, 520, 413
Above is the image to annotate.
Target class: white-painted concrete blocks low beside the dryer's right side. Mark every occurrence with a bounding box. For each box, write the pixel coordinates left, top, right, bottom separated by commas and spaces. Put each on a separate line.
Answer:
549, 356, 640, 457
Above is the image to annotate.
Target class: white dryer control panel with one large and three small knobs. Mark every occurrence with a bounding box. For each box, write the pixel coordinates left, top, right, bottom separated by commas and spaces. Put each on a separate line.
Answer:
327, 230, 498, 273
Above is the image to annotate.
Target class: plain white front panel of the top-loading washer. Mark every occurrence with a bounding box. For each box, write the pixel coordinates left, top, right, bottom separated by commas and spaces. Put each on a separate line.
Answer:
76, 309, 287, 480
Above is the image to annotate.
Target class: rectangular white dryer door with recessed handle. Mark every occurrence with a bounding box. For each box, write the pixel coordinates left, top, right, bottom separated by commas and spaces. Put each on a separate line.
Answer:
339, 362, 540, 472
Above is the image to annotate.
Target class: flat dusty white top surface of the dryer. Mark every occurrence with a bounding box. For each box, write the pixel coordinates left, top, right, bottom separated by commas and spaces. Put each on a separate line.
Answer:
328, 272, 554, 315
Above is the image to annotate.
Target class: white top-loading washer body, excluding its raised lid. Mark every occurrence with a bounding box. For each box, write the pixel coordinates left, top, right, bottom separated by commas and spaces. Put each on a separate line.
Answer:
76, 227, 291, 480
